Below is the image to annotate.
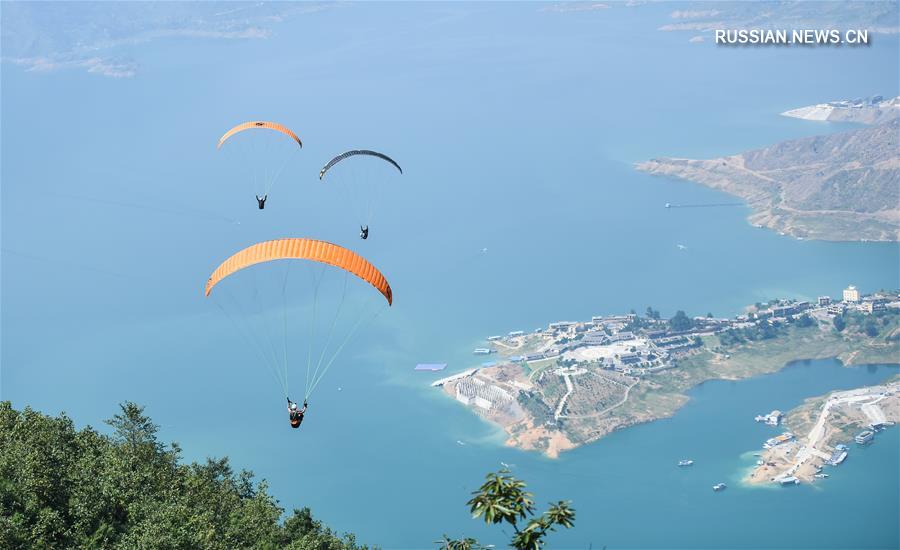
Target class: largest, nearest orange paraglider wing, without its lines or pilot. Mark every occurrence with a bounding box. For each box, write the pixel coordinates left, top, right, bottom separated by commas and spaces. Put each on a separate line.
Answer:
206, 239, 394, 305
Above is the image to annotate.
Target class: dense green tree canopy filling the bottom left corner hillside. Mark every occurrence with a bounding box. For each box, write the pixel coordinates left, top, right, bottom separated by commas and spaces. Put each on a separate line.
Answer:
0, 401, 363, 550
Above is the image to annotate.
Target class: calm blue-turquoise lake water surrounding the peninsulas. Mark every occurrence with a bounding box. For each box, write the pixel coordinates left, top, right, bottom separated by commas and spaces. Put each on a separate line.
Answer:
0, 4, 900, 548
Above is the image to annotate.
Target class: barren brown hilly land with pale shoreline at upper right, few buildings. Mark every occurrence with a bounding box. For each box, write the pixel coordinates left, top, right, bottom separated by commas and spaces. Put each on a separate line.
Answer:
636, 98, 900, 241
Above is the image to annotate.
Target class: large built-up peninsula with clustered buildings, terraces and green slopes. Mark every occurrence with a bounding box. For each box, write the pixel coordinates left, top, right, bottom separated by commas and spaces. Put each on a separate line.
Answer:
432, 286, 900, 457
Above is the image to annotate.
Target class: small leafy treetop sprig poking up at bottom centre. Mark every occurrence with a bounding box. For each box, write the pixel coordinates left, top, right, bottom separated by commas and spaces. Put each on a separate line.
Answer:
437, 469, 575, 550
